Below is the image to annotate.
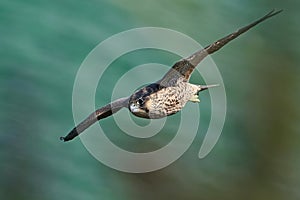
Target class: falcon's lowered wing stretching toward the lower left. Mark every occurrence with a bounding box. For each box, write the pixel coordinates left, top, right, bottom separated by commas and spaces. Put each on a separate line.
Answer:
60, 97, 129, 142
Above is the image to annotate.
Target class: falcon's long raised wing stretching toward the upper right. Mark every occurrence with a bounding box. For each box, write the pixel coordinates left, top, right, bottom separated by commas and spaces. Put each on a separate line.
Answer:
158, 10, 282, 86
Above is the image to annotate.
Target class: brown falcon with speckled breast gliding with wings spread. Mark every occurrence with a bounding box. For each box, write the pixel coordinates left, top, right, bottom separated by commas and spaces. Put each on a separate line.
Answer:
60, 10, 282, 142
